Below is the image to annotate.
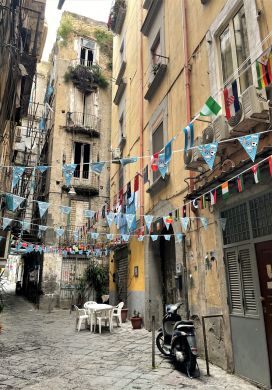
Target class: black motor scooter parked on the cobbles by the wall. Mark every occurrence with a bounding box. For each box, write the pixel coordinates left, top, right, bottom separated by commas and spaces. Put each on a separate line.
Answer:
156, 304, 198, 378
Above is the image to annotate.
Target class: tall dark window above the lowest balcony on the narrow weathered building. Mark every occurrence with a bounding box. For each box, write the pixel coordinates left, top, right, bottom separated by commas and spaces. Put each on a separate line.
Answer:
74, 142, 91, 179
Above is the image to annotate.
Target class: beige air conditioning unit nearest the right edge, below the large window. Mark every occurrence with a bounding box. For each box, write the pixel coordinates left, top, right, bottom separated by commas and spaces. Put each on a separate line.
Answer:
228, 85, 268, 135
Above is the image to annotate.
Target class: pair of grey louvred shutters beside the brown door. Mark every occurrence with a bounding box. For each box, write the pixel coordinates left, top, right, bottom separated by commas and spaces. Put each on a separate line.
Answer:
225, 246, 258, 316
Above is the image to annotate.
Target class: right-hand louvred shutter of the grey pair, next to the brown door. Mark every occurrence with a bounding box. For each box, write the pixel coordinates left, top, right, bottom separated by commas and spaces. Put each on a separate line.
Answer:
238, 247, 257, 314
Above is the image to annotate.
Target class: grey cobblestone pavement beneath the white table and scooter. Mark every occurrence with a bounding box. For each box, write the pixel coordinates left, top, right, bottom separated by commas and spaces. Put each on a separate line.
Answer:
0, 286, 256, 390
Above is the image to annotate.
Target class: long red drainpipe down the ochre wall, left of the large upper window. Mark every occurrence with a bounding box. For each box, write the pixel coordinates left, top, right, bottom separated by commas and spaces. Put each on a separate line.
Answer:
181, 0, 191, 319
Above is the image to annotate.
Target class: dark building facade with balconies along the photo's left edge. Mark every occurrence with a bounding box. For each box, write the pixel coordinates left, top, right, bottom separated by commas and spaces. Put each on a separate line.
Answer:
0, 0, 47, 268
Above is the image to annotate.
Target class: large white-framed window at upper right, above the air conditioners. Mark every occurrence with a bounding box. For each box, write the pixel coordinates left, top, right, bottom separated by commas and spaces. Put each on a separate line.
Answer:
219, 7, 252, 92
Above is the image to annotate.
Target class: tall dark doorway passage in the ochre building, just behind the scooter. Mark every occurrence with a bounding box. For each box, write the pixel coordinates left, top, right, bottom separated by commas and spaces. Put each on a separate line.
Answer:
159, 226, 177, 308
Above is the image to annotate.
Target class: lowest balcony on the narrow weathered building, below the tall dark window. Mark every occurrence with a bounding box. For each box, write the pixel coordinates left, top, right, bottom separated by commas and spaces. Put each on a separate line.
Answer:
71, 169, 99, 196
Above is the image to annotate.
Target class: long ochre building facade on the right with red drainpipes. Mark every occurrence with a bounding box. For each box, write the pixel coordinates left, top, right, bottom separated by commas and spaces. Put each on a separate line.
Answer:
109, 0, 272, 388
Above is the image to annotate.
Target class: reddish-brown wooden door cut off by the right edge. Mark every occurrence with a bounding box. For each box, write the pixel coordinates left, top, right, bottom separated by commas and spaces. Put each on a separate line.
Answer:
256, 241, 272, 371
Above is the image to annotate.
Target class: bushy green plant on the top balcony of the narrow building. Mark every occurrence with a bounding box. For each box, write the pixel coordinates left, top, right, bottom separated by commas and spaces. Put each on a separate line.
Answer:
64, 65, 109, 93
